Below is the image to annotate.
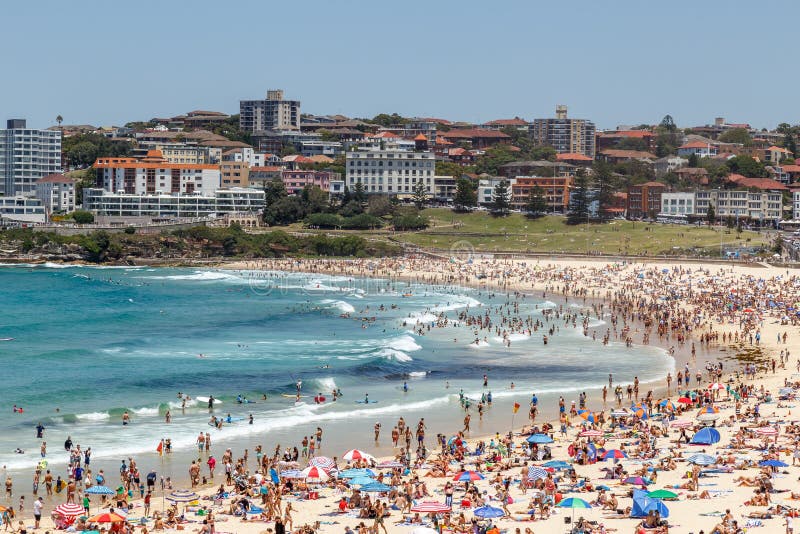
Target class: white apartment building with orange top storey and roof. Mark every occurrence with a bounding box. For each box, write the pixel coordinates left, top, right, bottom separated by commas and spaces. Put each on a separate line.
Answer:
94, 150, 220, 195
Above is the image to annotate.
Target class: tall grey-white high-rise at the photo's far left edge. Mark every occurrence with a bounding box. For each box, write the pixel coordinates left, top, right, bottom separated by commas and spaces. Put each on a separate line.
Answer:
0, 119, 61, 196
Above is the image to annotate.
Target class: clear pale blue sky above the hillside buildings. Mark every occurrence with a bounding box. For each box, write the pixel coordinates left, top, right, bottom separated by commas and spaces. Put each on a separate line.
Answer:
0, 0, 800, 128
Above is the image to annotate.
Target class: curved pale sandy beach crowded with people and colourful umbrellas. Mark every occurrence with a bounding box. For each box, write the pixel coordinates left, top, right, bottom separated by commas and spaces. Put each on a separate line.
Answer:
10, 257, 800, 533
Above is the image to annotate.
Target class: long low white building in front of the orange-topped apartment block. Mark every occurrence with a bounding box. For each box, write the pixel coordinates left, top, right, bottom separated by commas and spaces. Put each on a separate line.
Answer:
83, 187, 264, 219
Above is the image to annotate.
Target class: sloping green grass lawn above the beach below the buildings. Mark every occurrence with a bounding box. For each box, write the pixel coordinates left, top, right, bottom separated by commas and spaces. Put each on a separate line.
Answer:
384, 208, 769, 256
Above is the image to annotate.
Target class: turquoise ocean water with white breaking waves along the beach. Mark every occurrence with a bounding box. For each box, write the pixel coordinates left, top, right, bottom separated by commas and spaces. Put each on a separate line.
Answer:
0, 264, 674, 482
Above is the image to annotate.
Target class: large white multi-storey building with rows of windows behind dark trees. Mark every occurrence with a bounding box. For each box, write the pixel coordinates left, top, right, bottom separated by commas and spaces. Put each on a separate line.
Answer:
345, 150, 436, 196
